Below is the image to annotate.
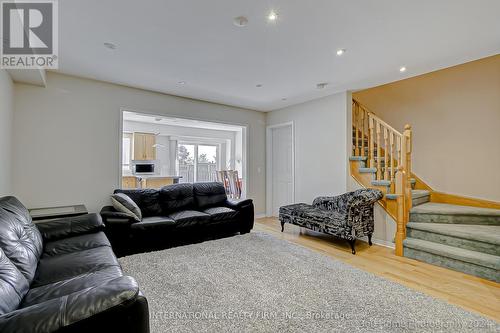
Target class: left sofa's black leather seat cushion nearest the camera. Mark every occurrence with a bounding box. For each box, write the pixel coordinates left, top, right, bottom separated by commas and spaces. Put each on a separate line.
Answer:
21, 266, 123, 308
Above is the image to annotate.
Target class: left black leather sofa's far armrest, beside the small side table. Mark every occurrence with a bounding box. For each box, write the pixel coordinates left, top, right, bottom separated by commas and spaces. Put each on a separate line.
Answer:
36, 214, 104, 241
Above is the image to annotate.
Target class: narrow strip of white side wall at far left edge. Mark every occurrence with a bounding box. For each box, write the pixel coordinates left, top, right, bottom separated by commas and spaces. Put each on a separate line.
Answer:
0, 70, 14, 196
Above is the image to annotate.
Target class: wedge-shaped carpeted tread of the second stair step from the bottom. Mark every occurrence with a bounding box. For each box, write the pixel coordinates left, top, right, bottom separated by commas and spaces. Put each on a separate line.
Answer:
407, 222, 500, 246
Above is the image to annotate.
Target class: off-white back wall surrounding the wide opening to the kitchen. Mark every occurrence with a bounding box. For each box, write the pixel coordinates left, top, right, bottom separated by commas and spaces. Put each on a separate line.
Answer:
13, 72, 266, 213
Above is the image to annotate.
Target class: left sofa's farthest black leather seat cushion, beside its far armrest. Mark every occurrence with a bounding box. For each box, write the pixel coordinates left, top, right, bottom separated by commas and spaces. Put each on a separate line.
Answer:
43, 231, 111, 257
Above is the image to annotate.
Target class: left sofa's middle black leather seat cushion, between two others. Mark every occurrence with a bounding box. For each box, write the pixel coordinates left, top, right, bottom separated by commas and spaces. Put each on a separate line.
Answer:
32, 246, 120, 287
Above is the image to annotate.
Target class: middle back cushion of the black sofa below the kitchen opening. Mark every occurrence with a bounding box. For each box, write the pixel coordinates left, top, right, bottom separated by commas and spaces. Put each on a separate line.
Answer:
160, 183, 194, 214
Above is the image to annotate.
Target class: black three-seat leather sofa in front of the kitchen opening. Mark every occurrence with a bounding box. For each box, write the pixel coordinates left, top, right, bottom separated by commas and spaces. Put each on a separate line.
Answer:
101, 182, 254, 254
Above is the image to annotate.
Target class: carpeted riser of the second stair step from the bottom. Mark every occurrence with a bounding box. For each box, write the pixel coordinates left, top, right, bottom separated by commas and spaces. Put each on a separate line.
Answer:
406, 228, 500, 256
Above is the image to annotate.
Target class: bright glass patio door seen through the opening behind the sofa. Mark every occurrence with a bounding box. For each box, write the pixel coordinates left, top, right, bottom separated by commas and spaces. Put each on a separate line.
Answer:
177, 143, 219, 183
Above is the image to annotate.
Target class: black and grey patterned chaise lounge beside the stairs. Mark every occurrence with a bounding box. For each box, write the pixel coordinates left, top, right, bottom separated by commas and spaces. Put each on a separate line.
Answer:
279, 189, 383, 254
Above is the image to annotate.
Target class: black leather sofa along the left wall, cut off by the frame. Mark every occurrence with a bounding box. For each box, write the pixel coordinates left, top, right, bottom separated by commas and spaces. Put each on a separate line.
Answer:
0, 196, 149, 333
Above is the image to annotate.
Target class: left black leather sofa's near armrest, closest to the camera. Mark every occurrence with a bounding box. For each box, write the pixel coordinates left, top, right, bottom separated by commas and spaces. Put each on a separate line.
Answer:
0, 276, 149, 333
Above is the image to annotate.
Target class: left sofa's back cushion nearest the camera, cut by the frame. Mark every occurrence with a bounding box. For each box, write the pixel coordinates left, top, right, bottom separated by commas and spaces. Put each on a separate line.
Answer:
0, 248, 29, 316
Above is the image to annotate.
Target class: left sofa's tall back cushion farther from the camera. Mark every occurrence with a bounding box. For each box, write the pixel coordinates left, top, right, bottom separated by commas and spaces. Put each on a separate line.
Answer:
0, 196, 43, 283
